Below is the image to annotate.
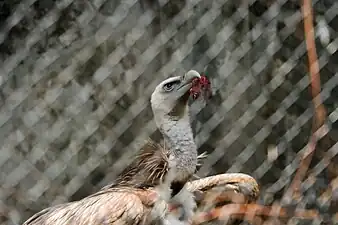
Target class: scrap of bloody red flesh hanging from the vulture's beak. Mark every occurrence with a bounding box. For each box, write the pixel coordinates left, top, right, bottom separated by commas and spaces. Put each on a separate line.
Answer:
190, 75, 211, 100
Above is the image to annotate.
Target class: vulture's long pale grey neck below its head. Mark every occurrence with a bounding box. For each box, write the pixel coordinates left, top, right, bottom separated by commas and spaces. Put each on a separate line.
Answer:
160, 115, 197, 180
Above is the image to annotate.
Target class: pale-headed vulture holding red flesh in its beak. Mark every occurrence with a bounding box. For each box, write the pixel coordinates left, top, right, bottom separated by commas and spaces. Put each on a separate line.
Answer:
23, 70, 258, 225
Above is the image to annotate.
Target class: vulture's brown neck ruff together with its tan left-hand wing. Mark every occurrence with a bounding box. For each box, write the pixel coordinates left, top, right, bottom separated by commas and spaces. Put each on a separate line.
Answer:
24, 140, 169, 225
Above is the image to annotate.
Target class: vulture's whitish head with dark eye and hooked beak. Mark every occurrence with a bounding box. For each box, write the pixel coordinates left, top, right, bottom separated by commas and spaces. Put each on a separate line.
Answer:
151, 70, 201, 125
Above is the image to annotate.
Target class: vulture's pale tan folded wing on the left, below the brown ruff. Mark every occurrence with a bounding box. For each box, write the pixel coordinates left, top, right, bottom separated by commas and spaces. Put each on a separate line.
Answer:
23, 187, 156, 225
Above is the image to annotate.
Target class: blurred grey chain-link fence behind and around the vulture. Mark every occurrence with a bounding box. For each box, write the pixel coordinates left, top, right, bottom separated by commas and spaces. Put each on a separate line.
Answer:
0, 0, 338, 225
